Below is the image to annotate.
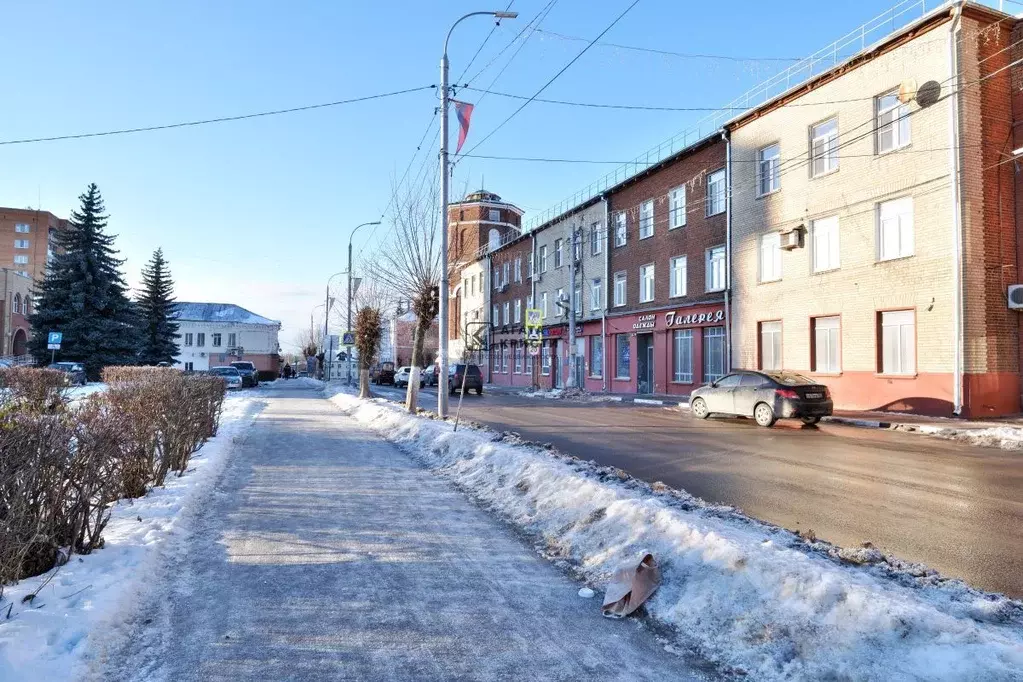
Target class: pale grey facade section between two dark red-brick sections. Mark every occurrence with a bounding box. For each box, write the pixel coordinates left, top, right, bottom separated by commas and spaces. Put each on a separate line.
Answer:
531, 197, 608, 391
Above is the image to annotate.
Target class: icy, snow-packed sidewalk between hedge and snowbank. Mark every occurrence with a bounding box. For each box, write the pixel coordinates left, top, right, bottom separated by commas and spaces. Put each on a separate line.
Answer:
100, 384, 698, 680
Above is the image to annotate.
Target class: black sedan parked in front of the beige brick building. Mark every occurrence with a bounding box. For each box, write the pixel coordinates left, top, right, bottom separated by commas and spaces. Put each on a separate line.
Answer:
690, 370, 834, 426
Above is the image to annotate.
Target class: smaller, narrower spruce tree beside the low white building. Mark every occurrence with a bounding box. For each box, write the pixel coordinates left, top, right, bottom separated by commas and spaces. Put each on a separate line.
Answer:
138, 248, 178, 365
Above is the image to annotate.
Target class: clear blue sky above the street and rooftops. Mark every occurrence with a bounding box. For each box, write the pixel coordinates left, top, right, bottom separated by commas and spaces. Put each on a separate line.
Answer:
0, 0, 1002, 348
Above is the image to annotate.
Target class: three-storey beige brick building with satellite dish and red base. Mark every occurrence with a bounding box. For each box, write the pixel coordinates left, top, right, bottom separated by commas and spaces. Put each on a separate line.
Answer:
728, 3, 1023, 416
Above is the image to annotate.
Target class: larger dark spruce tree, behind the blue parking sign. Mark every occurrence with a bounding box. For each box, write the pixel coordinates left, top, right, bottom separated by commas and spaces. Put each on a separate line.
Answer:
29, 183, 139, 379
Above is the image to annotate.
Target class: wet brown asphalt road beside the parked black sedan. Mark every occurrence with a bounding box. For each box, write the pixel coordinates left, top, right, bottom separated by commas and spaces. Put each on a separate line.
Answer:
373, 387, 1023, 597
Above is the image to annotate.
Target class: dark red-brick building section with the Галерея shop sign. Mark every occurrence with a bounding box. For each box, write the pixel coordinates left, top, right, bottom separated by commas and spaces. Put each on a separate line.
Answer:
604, 134, 727, 395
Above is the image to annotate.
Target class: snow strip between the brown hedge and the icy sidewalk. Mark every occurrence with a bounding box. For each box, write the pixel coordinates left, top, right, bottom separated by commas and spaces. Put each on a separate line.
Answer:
0, 392, 262, 682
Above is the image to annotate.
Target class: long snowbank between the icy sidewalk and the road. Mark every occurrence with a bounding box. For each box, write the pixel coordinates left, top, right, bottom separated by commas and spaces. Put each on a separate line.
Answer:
331, 393, 1023, 681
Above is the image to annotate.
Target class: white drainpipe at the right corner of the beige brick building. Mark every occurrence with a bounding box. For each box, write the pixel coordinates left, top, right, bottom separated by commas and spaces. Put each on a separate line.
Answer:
948, 0, 963, 416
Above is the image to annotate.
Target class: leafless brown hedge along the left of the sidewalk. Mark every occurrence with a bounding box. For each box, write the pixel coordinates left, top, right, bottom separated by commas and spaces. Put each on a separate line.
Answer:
0, 367, 224, 585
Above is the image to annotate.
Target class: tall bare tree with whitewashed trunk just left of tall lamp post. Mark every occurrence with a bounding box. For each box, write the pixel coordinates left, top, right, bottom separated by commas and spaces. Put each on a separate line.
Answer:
376, 180, 442, 413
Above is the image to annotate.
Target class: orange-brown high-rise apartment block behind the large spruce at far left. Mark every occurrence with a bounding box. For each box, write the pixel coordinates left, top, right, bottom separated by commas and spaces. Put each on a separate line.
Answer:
0, 208, 68, 281
